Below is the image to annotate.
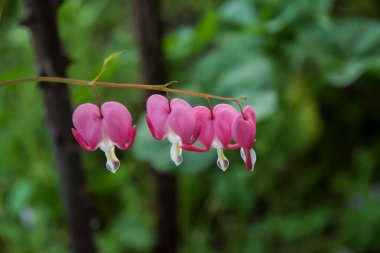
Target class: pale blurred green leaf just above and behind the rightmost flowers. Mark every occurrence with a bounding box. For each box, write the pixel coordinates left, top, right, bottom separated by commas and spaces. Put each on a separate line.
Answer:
195, 48, 277, 120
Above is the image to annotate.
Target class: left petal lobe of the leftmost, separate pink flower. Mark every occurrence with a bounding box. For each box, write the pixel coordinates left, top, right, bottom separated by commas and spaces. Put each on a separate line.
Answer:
73, 103, 103, 149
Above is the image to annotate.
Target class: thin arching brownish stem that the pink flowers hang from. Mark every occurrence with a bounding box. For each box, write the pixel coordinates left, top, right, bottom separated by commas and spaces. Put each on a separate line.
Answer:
0, 76, 246, 103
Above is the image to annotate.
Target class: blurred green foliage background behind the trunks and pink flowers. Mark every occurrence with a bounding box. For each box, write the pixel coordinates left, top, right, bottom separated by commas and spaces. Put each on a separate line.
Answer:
0, 0, 380, 253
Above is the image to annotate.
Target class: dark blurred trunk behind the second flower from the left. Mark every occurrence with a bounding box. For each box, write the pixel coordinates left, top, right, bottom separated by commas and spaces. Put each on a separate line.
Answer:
133, 0, 178, 253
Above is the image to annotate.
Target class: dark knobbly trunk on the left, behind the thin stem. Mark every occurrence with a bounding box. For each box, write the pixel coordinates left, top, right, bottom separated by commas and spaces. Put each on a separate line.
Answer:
21, 0, 96, 253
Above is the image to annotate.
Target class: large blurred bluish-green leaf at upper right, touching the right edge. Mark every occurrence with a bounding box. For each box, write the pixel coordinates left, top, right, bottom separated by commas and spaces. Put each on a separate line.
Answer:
300, 18, 380, 86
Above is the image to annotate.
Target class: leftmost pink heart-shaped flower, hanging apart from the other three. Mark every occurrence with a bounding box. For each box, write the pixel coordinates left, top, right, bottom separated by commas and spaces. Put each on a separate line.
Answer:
72, 102, 136, 173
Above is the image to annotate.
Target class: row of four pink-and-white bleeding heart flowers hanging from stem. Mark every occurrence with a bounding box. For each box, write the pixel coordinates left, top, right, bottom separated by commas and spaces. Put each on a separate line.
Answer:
72, 94, 256, 173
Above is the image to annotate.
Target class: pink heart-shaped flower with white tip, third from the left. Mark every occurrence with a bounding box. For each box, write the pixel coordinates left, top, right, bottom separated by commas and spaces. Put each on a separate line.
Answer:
182, 104, 240, 171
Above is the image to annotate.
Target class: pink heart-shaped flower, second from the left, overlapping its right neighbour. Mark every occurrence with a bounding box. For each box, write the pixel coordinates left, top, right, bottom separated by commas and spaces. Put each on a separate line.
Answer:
146, 94, 200, 166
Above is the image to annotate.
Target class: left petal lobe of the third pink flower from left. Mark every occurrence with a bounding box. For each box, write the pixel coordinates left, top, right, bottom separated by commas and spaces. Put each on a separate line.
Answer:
193, 106, 215, 149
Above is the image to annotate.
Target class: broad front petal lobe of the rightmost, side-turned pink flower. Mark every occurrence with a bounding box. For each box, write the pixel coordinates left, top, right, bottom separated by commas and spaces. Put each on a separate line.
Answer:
232, 115, 256, 148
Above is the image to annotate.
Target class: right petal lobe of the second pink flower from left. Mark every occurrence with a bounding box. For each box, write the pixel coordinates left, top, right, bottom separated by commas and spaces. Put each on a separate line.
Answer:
168, 98, 196, 144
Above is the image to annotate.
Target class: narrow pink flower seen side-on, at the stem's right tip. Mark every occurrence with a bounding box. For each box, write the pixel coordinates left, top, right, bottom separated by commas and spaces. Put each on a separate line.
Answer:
232, 106, 256, 171
